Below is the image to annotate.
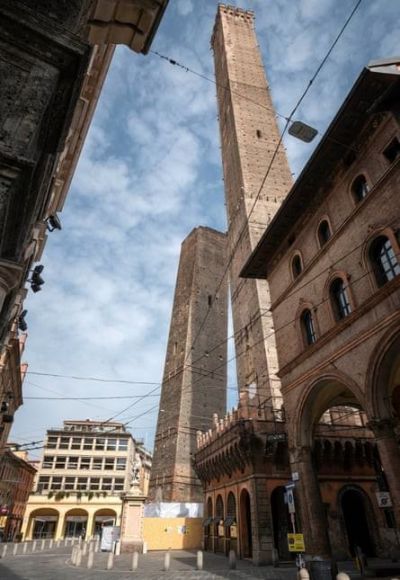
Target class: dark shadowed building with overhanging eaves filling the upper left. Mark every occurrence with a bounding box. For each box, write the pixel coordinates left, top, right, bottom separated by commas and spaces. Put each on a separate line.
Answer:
0, 0, 168, 454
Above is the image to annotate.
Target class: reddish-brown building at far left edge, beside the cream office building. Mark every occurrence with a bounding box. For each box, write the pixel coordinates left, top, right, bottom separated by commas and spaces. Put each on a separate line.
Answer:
0, 448, 36, 542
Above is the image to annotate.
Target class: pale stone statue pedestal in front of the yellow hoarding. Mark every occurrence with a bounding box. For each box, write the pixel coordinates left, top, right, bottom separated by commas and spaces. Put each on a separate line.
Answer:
121, 487, 146, 552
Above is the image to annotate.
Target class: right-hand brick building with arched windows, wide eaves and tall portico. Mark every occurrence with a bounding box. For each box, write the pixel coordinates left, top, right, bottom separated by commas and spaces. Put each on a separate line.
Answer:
243, 59, 400, 556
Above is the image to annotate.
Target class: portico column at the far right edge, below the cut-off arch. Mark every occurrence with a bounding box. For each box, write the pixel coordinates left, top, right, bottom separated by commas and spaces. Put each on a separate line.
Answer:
368, 419, 400, 528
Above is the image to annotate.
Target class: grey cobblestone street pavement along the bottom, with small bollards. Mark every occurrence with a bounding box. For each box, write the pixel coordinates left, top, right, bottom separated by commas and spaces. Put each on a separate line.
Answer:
0, 548, 296, 580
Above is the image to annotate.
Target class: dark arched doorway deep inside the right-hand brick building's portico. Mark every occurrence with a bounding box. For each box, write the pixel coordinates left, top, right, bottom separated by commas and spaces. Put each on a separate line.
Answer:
340, 487, 375, 557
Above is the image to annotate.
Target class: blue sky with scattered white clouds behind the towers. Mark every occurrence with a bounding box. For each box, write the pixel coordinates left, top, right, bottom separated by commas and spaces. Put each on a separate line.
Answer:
11, 0, 400, 457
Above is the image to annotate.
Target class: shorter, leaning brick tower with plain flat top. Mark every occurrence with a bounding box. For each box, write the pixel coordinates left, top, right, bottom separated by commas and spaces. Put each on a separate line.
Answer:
149, 227, 228, 502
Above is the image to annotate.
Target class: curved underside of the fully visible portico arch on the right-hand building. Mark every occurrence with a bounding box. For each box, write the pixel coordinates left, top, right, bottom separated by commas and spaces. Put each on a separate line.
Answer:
289, 371, 365, 447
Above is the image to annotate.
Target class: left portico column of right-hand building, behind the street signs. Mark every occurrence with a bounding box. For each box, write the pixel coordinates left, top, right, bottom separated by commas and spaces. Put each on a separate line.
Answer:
290, 446, 331, 558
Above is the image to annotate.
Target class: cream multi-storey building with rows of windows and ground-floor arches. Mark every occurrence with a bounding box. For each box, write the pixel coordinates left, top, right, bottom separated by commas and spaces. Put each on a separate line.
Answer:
22, 420, 148, 540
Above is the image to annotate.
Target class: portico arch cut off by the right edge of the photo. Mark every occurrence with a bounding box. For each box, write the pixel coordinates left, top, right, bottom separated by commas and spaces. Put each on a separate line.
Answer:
365, 321, 400, 420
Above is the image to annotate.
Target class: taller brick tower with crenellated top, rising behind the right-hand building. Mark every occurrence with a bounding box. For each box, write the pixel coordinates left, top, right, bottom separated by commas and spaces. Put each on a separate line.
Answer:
212, 4, 292, 413
